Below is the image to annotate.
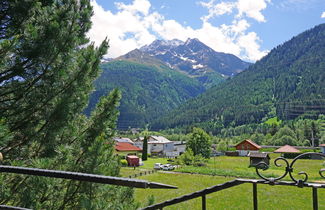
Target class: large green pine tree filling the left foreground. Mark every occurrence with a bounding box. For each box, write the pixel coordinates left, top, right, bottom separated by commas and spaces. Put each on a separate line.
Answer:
0, 0, 133, 209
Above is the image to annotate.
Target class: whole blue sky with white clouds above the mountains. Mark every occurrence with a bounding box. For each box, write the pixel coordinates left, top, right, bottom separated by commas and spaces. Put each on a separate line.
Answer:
88, 0, 325, 62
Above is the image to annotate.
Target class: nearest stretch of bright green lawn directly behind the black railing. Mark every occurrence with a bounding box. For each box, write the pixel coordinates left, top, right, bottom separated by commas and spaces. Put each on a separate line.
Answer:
135, 172, 325, 210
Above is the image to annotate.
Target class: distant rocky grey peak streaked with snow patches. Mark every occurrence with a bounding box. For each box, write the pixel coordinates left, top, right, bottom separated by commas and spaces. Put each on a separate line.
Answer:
140, 39, 250, 87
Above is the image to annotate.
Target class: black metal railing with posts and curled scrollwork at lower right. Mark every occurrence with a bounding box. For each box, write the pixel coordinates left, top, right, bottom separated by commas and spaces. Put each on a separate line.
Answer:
143, 152, 325, 210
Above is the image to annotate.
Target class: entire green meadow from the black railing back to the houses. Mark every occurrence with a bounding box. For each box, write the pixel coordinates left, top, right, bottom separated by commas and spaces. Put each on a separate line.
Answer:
123, 154, 325, 209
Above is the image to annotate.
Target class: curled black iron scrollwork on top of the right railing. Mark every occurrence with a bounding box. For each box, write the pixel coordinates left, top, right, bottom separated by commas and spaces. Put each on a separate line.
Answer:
255, 152, 325, 187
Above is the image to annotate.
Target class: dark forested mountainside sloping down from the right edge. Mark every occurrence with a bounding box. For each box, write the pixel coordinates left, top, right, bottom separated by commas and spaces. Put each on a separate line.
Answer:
151, 24, 325, 131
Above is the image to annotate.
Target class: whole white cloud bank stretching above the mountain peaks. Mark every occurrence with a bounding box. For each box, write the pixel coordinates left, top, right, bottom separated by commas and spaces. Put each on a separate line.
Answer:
88, 0, 267, 61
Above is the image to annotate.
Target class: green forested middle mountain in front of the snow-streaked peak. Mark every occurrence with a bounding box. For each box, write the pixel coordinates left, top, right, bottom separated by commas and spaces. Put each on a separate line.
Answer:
85, 60, 205, 129
